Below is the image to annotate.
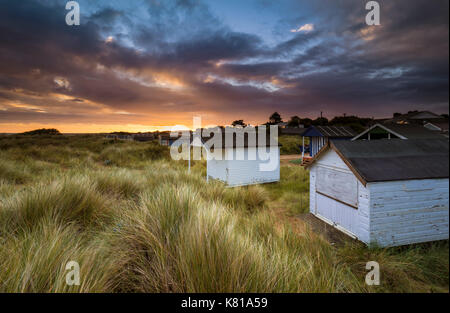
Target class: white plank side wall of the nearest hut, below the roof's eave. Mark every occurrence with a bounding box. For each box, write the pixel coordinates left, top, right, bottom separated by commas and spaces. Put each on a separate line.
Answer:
367, 179, 449, 246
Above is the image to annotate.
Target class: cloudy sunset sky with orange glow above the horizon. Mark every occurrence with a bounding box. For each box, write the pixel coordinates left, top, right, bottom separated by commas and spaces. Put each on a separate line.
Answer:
0, 0, 449, 133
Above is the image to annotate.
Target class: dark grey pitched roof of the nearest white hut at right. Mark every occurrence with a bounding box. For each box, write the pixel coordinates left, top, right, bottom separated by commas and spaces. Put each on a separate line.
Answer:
331, 139, 449, 182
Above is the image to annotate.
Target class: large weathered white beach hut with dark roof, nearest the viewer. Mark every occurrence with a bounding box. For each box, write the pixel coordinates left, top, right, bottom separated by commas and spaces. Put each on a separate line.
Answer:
308, 139, 449, 246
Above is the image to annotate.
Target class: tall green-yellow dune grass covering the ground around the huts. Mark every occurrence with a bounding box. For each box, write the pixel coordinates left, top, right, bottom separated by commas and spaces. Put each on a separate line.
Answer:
0, 135, 449, 292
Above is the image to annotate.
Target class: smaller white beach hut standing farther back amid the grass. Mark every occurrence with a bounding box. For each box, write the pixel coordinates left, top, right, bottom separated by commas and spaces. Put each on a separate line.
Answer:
206, 131, 280, 187
